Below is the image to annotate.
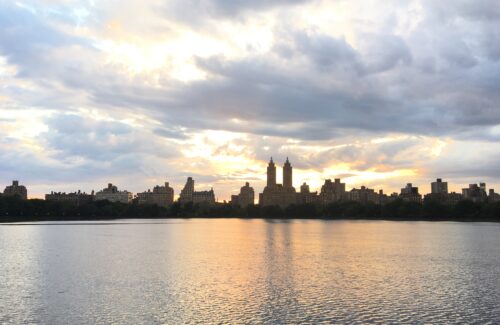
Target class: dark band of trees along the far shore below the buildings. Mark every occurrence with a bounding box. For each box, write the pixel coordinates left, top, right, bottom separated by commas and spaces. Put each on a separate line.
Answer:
0, 196, 500, 222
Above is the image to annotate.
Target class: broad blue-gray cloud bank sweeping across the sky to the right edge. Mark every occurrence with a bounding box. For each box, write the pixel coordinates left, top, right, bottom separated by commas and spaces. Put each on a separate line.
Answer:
2, 0, 500, 143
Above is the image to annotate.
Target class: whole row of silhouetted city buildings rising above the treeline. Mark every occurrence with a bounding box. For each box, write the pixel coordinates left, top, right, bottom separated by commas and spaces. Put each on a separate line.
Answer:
3, 158, 500, 208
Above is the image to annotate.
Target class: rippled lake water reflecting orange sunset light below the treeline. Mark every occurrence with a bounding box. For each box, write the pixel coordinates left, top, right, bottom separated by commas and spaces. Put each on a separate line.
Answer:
0, 219, 500, 324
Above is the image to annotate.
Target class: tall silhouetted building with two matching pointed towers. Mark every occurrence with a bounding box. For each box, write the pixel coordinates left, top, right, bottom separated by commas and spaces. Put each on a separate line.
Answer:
259, 157, 297, 208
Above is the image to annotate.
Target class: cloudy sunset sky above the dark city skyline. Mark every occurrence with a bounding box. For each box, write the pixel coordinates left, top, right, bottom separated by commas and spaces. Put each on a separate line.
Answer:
0, 0, 500, 201
